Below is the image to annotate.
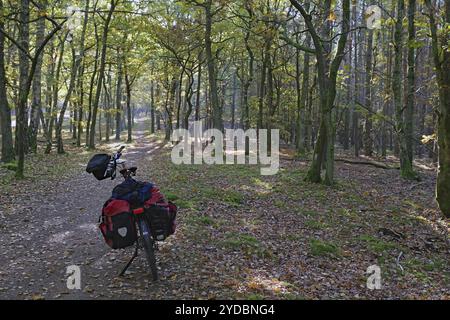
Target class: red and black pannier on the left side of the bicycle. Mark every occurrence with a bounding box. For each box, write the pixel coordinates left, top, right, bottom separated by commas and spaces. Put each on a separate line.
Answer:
99, 199, 137, 249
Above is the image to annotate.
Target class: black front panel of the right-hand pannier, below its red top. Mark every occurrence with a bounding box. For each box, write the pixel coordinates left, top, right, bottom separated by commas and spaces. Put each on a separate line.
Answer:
145, 205, 173, 241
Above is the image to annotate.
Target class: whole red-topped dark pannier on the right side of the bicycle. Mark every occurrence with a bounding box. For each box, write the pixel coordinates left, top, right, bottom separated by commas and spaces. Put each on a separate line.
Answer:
144, 187, 178, 241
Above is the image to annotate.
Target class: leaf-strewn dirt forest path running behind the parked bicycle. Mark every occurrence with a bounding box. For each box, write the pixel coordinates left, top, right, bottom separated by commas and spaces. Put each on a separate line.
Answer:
0, 121, 181, 299
